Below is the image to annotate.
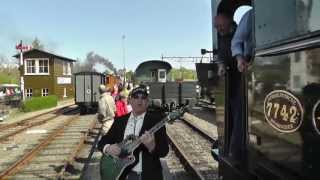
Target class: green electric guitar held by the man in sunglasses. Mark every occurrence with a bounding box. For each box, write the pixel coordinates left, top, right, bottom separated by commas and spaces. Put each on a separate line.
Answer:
100, 107, 186, 180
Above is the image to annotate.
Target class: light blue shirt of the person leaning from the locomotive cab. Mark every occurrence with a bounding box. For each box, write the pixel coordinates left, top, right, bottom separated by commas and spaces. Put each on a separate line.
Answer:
231, 9, 253, 57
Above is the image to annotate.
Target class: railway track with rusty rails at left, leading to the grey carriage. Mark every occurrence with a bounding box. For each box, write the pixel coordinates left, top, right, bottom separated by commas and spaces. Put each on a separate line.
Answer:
0, 107, 93, 179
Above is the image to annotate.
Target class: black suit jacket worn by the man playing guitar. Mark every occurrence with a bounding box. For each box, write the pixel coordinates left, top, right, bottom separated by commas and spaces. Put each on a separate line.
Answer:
98, 111, 169, 180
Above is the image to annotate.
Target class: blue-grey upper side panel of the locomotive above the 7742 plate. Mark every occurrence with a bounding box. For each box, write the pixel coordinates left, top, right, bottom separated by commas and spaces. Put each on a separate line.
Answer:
255, 0, 320, 48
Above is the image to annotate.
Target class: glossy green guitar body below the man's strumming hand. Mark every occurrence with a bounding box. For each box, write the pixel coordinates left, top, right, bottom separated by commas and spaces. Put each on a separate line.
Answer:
100, 154, 135, 180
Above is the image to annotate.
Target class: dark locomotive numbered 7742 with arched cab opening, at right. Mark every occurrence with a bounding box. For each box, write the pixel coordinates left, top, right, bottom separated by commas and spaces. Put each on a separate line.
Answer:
205, 0, 320, 180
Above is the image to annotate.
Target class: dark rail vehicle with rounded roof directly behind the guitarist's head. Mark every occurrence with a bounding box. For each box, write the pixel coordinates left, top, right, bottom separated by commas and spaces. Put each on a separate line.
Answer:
134, 60, 199, 108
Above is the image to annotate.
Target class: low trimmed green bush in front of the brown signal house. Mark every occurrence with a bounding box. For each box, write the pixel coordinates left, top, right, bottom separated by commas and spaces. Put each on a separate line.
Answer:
21, 95, 58, 112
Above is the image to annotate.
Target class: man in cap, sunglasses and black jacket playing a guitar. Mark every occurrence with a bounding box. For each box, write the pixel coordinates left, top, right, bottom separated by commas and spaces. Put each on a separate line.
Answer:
98, 86, 169, 180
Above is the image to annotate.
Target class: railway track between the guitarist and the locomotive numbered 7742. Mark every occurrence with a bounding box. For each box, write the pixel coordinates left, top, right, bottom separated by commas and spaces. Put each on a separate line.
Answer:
167, 114, 219, 180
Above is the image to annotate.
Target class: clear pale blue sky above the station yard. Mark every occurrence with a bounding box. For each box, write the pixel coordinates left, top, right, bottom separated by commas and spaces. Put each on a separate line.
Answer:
0, 0, 212, 70
